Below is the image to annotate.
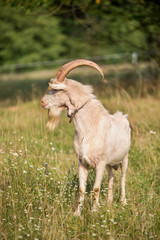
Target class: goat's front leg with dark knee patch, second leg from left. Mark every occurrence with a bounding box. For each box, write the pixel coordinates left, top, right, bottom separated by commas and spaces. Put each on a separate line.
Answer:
92, 163, 105, 211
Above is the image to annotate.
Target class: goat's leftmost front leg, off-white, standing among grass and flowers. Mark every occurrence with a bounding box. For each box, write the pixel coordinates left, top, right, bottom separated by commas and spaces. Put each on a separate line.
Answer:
74, 163, 88, 216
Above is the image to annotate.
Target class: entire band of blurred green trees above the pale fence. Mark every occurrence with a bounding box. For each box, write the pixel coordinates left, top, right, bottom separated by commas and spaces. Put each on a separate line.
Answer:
0, 0, 160, 64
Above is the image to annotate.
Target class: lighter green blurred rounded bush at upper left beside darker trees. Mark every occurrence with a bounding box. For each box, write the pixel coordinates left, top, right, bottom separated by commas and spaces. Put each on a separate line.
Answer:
0, 7, 65, 64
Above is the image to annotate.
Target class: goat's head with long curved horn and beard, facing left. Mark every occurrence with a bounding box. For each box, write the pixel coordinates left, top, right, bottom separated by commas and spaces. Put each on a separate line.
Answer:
41, 59, 104, 130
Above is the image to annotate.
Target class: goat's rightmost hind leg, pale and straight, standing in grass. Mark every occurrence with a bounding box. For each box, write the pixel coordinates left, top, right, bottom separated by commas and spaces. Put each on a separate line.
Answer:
121, 153, 128, 205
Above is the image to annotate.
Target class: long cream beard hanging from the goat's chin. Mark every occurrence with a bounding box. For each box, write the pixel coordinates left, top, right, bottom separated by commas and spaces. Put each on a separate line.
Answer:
47, 107, 62, 131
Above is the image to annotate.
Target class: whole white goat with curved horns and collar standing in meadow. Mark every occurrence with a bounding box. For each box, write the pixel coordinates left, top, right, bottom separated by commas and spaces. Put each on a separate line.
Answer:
41, 59, 131, 216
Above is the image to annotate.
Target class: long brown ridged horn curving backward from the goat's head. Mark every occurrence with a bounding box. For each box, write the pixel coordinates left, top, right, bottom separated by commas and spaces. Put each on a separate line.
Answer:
55, 59, 104, 82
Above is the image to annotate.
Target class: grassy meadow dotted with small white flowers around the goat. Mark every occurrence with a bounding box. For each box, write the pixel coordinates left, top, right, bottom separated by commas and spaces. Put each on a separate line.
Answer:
0, 64, 160, 240
